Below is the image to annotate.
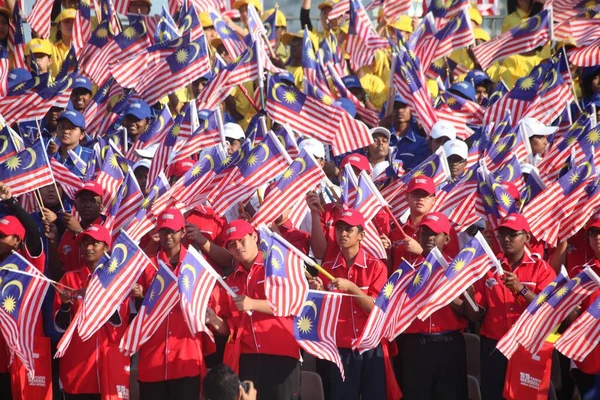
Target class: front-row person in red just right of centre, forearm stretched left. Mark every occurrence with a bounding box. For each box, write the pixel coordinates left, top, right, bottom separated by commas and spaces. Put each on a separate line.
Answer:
309, 208, 387, 400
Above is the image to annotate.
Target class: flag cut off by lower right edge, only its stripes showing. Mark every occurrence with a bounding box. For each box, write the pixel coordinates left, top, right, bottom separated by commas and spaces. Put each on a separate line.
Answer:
554, 297, 600, 361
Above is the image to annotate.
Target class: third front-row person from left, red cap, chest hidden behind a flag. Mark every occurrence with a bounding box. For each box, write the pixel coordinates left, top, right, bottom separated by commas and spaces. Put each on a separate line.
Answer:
138, 208, 214, 400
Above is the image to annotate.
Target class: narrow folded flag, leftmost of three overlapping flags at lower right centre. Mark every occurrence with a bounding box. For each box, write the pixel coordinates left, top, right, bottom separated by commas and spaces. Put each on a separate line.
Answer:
352, 260, 415, 353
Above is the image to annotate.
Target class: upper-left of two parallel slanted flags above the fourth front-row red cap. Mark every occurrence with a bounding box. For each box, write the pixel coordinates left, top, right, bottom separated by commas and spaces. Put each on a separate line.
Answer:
209, 132, 289, 213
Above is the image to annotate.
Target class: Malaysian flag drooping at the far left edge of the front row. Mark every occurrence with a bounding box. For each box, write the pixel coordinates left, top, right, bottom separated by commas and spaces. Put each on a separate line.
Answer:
0, 252, 50, 377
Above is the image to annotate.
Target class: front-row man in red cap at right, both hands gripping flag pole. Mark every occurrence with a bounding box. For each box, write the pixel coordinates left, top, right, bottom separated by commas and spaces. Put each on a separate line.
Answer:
466, 214, 556, 399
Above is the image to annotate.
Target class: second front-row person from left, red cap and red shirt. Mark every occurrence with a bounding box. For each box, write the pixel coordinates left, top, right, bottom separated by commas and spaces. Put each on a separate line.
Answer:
54, 224, 129, 399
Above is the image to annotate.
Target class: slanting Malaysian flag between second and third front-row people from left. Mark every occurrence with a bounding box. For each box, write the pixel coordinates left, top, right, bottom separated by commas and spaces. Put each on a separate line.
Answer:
78, 232, 150, 341
